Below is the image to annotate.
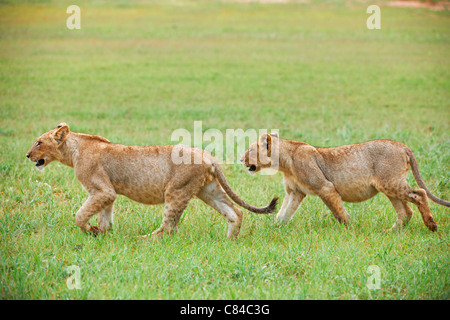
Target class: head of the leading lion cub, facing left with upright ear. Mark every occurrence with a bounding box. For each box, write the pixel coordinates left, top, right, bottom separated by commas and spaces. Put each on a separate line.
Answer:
27, 122, 70, 170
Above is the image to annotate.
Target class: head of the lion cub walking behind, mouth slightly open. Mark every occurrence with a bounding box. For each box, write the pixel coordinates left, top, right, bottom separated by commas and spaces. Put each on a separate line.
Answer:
241, 133, 279, 174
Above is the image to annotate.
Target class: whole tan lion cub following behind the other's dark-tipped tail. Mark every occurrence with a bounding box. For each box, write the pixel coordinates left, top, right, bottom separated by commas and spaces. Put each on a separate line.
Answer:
241, 135, 450, 231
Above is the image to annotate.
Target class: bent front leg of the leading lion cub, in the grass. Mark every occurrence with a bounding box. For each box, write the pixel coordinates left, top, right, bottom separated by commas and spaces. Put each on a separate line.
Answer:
75, 191, 116, 233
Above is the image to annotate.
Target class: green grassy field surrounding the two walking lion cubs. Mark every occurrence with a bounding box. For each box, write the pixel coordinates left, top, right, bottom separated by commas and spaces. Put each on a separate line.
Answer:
0, 1, 450, 299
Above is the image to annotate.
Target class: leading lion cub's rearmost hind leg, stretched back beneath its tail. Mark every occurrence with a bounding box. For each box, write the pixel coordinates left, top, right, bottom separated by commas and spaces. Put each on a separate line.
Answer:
197, 180, 243, 239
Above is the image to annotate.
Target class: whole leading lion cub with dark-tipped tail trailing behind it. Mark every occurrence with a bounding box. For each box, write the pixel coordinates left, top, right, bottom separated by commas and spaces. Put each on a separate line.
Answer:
27, 123, 276, 238
